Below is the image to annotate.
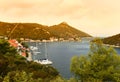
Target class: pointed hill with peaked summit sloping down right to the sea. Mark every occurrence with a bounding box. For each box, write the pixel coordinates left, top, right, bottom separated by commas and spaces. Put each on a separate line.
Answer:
49, 22, 90, 39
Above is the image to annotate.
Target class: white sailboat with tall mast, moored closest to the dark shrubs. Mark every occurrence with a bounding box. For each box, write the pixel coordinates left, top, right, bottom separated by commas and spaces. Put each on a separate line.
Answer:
34, 42, 53, 65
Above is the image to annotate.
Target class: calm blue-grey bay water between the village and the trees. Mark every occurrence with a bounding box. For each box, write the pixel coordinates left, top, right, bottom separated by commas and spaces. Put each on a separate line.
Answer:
28, 40, 120, 78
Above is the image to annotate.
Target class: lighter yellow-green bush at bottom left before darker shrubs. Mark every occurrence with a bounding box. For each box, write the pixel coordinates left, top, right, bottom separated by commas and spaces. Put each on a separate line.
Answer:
3, 71, 42, 82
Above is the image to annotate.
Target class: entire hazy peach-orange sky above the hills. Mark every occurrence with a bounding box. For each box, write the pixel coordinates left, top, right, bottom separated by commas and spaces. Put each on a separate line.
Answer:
0, 0, 120, 36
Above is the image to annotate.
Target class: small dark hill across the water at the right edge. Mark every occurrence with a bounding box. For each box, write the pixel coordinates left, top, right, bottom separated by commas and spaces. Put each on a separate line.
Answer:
103, 34, 120, 46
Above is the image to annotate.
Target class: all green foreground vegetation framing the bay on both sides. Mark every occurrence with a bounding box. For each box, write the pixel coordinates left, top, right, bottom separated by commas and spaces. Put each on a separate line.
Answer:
0, 39, 120, 82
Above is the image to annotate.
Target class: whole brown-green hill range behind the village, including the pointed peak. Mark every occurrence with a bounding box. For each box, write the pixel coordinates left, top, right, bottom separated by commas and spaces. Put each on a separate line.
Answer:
0, 22, 90, 40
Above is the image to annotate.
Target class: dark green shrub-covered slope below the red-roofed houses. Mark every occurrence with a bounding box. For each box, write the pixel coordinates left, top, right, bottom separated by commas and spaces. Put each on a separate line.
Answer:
0, 40, 59, 82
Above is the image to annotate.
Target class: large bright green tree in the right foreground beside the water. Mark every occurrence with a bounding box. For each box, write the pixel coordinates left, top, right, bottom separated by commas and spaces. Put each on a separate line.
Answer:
71, 39, 120, 82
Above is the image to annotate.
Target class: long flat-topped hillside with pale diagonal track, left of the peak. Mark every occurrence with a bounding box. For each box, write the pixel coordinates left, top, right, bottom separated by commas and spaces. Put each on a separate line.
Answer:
0, 22, 53, 39
